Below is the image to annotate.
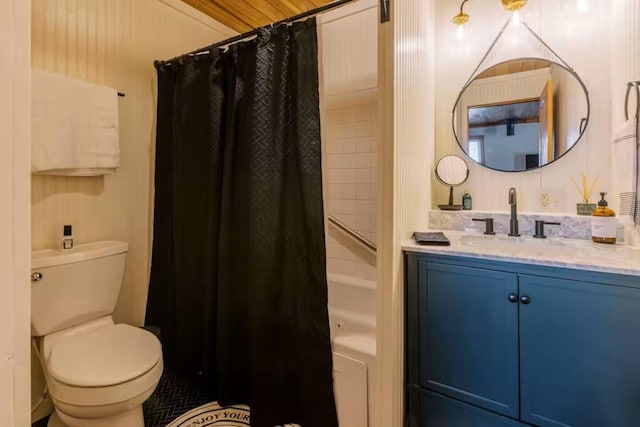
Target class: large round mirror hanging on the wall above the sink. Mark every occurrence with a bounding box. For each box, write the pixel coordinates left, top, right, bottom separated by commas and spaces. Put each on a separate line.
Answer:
453, 58, 589, 172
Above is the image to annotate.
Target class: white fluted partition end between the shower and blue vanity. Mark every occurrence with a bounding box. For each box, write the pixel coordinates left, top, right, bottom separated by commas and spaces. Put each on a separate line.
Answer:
374, 0, 436, 427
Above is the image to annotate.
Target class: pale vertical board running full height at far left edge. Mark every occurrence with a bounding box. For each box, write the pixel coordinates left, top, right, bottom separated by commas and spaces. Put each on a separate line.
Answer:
0, 0, 31, 427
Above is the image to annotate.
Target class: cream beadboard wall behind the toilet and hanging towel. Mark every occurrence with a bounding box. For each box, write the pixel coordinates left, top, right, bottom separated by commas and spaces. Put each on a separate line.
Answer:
31, 0, 234, 325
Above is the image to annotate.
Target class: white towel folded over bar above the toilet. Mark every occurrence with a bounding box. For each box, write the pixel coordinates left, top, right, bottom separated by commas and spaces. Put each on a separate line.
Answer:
31, 69, 120, 176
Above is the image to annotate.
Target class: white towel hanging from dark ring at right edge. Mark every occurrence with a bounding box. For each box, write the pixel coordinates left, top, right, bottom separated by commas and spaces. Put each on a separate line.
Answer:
613, 118, 640, 225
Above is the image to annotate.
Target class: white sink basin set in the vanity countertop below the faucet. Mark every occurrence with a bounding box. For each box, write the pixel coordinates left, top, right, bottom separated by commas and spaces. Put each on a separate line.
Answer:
460, 235, 578, 257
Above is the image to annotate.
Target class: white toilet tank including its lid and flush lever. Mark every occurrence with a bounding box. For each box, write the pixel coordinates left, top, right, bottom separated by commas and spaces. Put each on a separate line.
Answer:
31, 241, 128, 336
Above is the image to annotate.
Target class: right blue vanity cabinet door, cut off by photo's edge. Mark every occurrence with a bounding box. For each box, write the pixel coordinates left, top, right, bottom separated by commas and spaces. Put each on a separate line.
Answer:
520, 275, 640, 427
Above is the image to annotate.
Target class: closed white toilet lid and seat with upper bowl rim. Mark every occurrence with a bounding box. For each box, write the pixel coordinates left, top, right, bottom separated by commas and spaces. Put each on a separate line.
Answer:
47, 324, 163, 407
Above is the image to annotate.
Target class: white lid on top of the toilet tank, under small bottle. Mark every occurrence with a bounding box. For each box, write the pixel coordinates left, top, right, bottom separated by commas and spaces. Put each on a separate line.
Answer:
31, 240, 129, 269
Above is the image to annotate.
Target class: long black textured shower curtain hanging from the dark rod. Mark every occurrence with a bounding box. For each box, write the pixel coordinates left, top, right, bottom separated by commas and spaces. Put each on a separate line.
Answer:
146, 19, 337, 427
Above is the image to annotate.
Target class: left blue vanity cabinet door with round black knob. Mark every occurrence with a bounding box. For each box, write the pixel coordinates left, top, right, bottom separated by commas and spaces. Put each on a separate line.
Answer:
418, 262, 518, 418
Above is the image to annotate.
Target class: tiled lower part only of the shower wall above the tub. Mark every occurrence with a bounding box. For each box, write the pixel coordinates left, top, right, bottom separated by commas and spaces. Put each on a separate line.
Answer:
322, 89, 377, 280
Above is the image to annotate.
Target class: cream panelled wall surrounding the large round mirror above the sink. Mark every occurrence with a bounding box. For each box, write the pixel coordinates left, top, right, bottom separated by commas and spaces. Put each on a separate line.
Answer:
432, 0, 618, 214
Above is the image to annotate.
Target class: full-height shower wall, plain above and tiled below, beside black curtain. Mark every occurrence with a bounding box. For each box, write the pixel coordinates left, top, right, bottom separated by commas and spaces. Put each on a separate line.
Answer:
319, 0, 378, 280
